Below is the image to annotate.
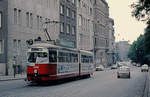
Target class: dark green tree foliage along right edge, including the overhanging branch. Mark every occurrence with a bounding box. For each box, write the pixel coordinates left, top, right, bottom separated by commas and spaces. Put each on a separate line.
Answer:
131, 0, 150, 64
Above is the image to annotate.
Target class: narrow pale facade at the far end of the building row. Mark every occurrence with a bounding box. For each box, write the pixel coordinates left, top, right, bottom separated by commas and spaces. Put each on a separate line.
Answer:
107, 18, 116, 66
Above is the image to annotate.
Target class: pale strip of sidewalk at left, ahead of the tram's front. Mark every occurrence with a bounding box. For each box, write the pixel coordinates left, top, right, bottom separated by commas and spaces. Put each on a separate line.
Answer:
0, 74, 26, 81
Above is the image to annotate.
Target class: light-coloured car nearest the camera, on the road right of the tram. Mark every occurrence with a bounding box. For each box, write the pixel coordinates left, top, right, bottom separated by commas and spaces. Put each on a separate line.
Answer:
117, 66, 131, 78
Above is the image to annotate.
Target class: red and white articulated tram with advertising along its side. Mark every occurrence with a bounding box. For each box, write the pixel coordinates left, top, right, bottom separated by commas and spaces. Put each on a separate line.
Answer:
27, 43, 93, 81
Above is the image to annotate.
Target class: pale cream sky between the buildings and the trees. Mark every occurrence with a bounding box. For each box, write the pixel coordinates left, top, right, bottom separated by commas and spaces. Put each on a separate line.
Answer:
106, 0, 146, 43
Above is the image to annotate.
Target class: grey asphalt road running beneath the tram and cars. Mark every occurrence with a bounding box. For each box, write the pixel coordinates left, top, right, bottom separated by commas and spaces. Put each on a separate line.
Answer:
0, 68, 147, 97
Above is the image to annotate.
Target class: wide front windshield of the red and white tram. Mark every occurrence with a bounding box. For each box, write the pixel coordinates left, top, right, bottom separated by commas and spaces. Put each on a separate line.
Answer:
28, 52, 48, 63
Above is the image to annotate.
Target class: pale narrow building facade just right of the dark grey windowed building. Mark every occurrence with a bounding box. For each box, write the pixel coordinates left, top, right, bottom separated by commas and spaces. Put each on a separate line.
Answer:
76, 0, 94, 51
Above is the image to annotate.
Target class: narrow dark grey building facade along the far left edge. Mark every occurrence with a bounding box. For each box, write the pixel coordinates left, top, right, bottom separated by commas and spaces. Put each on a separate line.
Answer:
0, 0, 8, 74
